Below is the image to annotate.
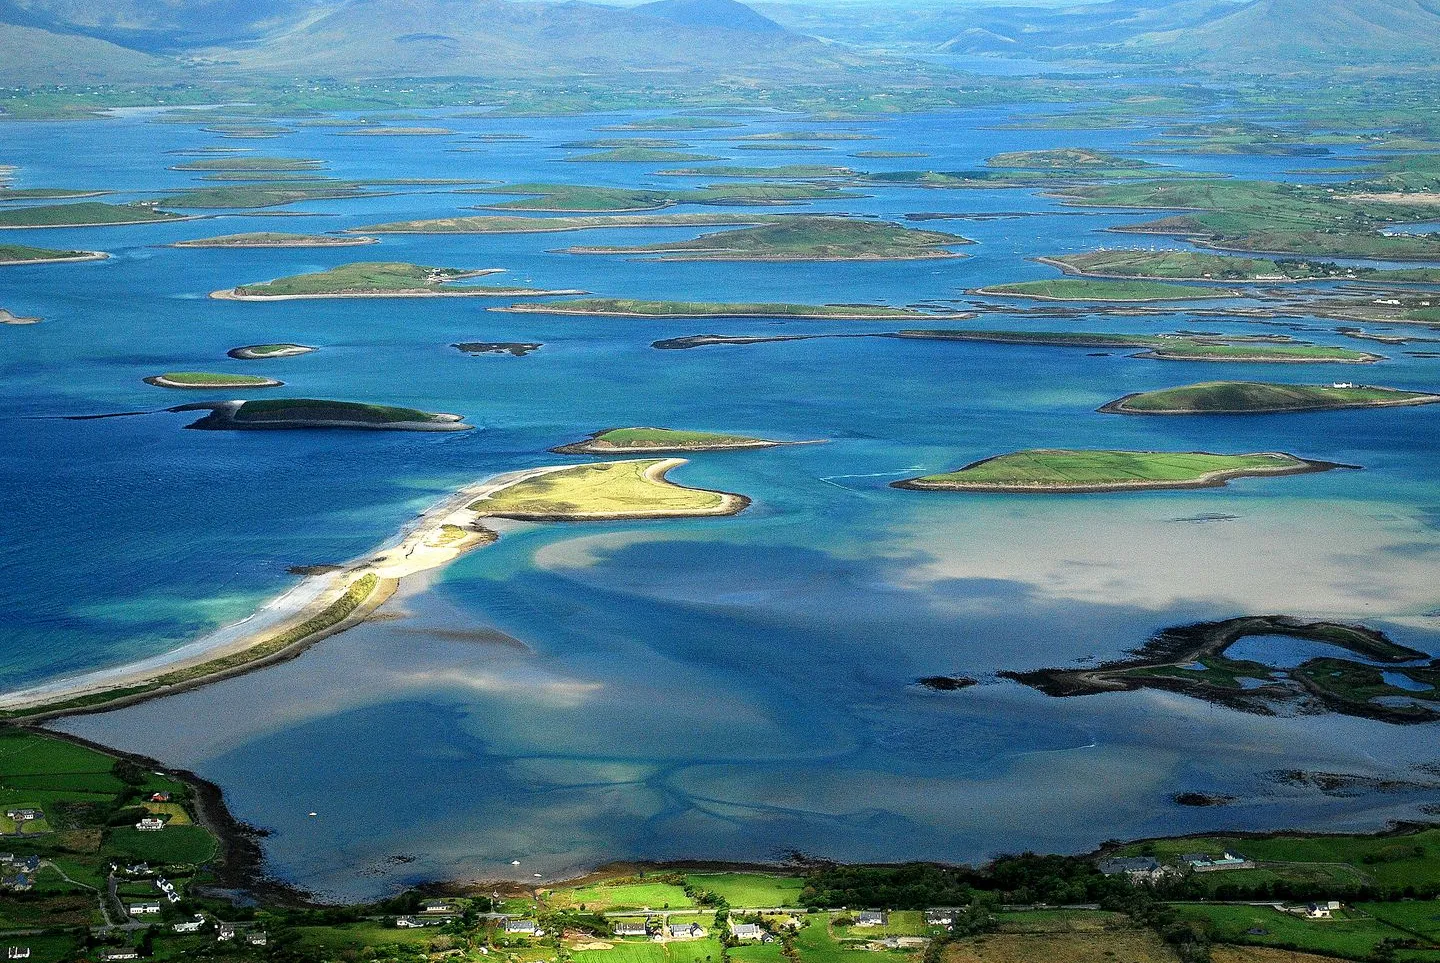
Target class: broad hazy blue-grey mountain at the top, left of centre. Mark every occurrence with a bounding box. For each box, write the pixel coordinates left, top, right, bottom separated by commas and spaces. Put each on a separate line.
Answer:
209, 0, 840, 78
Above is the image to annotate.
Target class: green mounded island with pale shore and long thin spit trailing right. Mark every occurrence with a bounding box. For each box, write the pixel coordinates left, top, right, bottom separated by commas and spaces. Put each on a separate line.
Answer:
210, 261, 585, 301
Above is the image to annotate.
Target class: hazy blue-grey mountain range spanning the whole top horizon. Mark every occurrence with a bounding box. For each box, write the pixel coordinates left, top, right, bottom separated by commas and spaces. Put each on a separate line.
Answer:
0, 0, 1440, 85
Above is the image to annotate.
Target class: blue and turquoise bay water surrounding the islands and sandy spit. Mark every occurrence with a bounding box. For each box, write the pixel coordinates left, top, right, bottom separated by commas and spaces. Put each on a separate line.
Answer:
0, 111, 1440, 897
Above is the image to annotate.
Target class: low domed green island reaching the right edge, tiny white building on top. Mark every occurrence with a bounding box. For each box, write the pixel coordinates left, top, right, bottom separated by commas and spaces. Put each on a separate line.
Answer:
1099, 381, 1440, 415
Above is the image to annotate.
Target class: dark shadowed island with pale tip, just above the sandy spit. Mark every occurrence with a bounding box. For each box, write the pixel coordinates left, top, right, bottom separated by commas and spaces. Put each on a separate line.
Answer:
168, 397, 474, 432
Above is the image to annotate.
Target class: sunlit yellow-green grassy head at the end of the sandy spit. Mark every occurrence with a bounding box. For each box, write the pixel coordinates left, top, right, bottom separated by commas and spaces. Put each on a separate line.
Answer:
471, 458, 750, 521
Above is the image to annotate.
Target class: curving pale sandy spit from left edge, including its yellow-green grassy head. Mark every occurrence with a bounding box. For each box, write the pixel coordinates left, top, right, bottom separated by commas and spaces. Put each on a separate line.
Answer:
0, 460, 750, 723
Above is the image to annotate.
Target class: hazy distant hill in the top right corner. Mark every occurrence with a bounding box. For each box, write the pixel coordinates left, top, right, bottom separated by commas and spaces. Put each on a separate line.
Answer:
1126, 0, 1440, 65
